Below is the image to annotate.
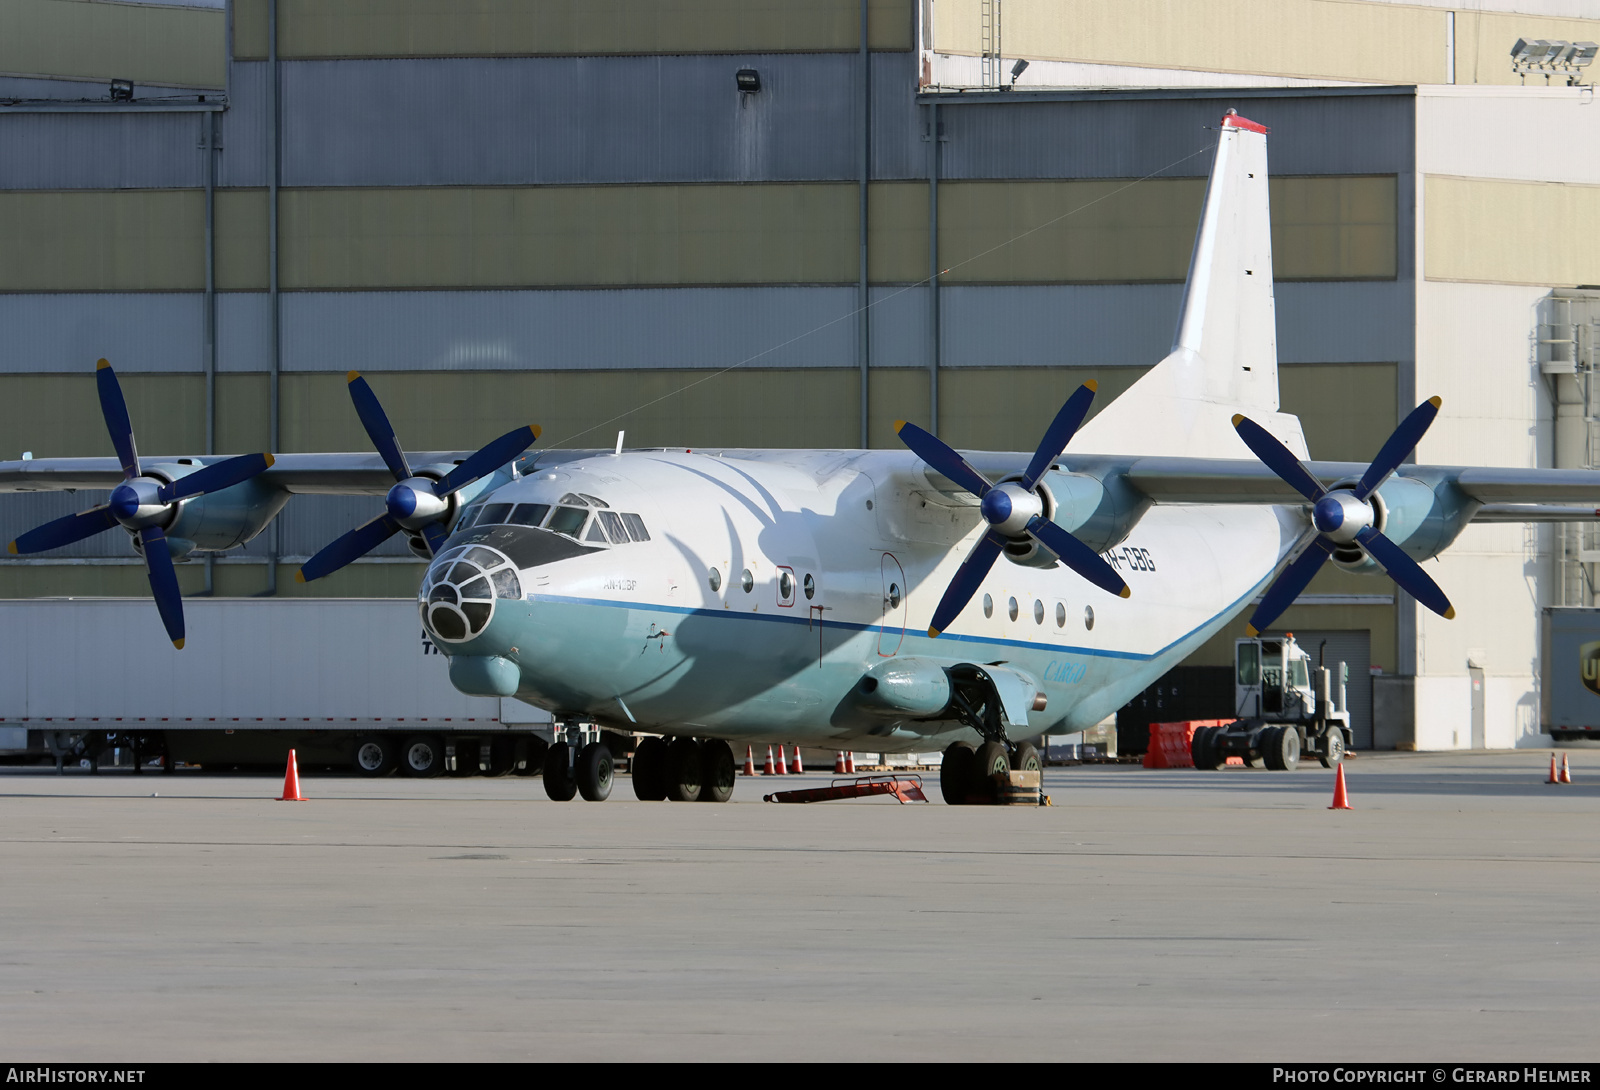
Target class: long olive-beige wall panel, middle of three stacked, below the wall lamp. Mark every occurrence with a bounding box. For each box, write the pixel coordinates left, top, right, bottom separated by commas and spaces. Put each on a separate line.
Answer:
280, 184, 859, 290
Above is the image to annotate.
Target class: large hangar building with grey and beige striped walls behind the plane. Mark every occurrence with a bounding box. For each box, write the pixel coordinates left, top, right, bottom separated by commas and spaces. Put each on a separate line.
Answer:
0, 0, 1600, 749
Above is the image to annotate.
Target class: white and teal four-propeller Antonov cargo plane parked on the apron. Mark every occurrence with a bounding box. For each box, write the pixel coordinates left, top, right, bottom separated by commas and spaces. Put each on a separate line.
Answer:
0, 110, 1600, 802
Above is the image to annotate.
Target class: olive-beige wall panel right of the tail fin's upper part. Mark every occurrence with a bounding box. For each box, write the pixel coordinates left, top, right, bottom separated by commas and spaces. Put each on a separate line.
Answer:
1269, 174, 1400, 280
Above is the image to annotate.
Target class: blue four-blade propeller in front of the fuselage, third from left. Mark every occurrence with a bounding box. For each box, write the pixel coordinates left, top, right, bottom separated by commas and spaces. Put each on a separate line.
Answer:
894, 383, 1128, 637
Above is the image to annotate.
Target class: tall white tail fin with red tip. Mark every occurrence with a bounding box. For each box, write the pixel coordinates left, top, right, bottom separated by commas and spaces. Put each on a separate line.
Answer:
1072, 110, 1306, 458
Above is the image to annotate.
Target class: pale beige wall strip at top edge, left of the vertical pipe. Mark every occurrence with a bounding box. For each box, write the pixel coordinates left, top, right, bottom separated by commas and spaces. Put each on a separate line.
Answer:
933, 0, 1446, 83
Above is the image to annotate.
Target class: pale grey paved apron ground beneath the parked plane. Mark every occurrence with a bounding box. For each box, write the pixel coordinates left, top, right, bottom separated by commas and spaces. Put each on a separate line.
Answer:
0, 751, 1600, 1064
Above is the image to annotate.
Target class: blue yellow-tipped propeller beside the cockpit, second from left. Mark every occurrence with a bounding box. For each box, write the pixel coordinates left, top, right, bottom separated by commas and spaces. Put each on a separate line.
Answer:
294, 371, 539, 583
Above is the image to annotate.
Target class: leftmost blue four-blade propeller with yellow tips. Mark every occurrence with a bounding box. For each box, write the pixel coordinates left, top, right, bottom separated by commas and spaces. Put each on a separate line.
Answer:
10, 360, 272, 650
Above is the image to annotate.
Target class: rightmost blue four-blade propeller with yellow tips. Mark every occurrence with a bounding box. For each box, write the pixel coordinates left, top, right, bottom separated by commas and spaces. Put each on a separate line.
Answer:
1234, 397, 1456, 635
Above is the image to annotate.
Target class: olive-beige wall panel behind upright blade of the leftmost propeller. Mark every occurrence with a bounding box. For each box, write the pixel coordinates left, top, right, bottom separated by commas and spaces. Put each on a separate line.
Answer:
0, 374, 204, 459
